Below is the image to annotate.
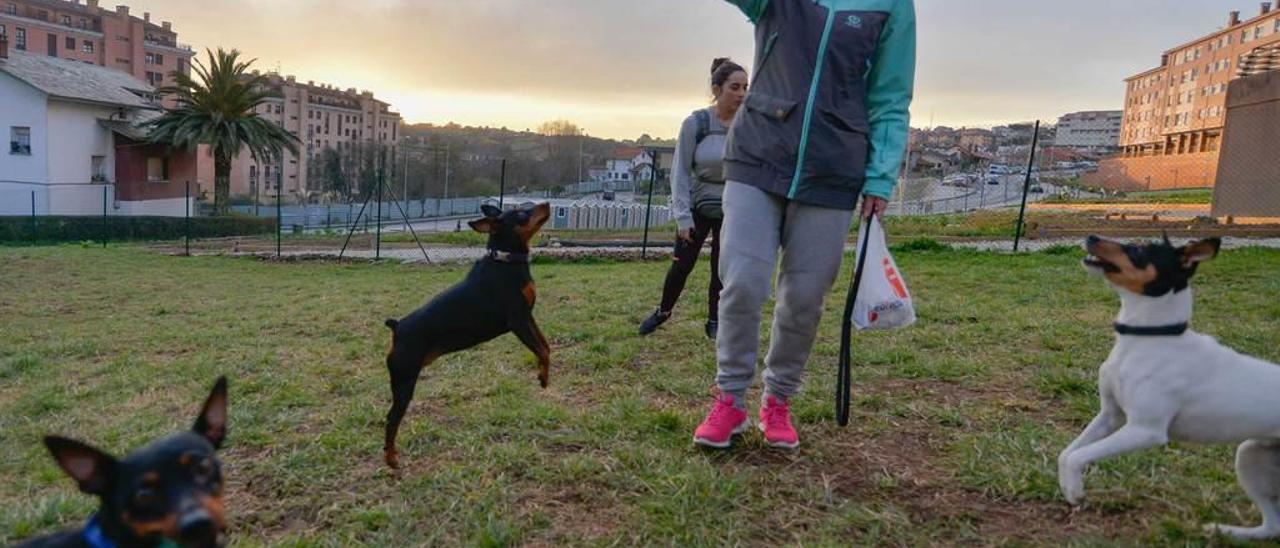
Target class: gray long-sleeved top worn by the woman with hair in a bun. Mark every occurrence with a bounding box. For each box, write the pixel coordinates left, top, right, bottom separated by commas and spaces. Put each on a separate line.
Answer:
671, 106, 728, 229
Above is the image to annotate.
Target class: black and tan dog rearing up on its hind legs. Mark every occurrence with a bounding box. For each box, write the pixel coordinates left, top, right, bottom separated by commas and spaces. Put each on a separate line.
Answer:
383, 204, 550, 469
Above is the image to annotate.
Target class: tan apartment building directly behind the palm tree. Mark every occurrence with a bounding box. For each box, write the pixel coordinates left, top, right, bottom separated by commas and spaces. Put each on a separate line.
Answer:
227, 73, 401, 201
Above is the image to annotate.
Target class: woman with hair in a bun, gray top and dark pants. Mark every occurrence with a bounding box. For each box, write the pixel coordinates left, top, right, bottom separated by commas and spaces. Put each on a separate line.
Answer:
640, 58, 748, 338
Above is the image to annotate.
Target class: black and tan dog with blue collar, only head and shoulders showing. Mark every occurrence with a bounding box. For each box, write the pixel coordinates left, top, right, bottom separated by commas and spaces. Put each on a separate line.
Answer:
22, 376, 227, 548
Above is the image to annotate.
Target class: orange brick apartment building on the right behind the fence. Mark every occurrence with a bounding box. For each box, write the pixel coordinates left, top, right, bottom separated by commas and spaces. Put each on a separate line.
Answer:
1087, 3, 1280, 189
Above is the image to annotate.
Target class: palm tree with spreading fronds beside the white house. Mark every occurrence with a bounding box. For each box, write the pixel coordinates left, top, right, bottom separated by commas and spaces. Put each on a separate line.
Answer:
147, 47, 298, 215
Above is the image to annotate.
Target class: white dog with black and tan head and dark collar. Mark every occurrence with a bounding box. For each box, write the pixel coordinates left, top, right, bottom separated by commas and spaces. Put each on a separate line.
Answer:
1057, 237, 1280, 539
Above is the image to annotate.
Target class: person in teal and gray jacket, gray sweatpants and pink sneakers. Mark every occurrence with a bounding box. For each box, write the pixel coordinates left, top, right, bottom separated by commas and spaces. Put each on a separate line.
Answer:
694, 0, 915, 448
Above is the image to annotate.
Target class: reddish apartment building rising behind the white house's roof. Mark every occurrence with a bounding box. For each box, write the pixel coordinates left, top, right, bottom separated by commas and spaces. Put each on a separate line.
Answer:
0, 0, 193, 86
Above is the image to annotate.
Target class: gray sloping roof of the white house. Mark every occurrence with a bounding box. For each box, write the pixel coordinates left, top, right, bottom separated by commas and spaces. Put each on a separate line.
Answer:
0, 50, 159, 109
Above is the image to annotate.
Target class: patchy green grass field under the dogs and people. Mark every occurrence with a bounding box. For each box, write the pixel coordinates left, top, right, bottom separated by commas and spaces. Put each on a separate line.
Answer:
0, 246, 1280, 547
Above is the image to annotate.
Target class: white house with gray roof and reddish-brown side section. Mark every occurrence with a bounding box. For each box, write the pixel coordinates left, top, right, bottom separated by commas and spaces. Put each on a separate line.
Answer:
0, 41, 195, 216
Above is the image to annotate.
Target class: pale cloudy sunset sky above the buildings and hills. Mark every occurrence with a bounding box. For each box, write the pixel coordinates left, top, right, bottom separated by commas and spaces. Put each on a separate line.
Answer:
124, 0, 1260, 138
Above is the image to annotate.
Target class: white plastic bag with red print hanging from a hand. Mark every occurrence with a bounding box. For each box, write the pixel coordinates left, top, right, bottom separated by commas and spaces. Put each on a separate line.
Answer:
852, 218, 915, 330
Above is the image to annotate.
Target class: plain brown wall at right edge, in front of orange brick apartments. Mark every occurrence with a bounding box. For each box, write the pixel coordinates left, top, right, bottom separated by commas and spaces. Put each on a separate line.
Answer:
1213, 70, 1280, 218
